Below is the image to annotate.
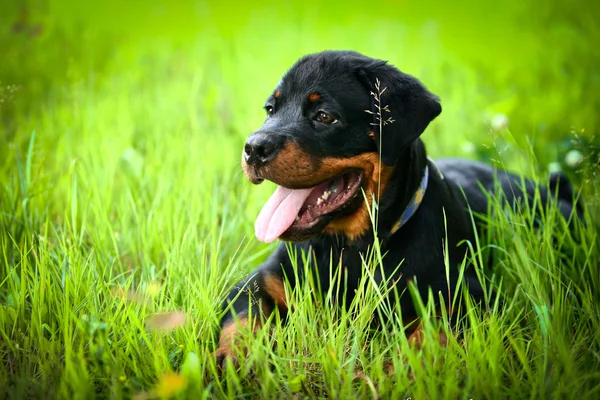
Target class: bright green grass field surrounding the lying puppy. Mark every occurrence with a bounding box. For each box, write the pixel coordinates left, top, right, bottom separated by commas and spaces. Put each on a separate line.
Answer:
0, 0, 600, 399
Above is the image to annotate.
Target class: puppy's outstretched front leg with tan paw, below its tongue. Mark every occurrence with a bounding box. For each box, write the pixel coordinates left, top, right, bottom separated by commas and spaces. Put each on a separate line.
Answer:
215, 245, 293, 365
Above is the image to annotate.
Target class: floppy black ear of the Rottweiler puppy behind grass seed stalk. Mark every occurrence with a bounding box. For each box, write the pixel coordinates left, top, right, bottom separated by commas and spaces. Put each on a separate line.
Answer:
358, 62, 442, 165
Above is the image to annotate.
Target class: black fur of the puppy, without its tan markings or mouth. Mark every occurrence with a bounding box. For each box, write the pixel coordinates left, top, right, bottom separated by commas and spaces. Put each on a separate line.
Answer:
218, 51, 573, 356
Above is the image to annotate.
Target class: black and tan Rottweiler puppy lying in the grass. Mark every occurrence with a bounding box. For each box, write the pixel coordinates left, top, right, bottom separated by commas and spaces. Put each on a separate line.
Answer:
217, 51, 573, 360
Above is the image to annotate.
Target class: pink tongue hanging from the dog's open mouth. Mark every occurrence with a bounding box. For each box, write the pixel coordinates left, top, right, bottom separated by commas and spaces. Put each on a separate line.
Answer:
254, 186, 314, 243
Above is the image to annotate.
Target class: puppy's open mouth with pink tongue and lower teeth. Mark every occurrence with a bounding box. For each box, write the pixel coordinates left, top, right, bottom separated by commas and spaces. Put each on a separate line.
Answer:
254, 170, 363, 243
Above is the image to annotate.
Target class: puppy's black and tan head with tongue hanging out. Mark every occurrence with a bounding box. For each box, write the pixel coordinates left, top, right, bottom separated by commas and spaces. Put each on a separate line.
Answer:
242, 51, 441, 242
